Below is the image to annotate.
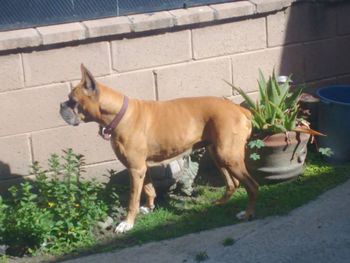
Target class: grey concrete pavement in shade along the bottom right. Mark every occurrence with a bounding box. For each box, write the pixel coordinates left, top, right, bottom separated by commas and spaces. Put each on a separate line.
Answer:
65, 180, 350, 263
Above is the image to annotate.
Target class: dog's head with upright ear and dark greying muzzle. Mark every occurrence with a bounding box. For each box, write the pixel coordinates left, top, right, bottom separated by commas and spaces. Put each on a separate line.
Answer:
60, 64, 101, 126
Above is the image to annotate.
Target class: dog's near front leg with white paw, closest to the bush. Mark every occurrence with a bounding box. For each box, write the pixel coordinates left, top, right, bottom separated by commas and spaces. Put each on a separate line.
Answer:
115, 167, 147, 233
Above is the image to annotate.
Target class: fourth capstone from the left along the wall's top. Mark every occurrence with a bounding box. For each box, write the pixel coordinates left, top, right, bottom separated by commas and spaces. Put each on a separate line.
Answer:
128, 11, 174, 32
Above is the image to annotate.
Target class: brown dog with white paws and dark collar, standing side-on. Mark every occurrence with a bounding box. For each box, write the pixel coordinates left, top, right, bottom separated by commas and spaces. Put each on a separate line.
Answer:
60, 65, 258, 233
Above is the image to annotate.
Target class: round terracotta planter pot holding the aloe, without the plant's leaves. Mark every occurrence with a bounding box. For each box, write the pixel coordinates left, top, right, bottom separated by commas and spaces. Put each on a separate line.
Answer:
246, 132, 310, 184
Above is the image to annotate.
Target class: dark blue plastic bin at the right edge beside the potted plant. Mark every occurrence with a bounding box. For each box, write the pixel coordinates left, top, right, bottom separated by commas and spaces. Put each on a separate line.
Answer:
317, 85, 350, 163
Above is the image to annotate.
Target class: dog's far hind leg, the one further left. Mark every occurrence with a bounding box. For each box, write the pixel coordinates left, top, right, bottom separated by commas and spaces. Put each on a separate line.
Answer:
208, 147, 239, 205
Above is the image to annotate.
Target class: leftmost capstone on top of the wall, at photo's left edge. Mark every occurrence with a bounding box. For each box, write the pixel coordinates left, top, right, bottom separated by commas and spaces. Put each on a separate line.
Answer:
0, 28, 41, 51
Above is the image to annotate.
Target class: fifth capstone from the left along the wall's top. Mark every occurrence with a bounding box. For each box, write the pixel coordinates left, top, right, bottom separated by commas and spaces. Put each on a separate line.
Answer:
169, 6, 214, 26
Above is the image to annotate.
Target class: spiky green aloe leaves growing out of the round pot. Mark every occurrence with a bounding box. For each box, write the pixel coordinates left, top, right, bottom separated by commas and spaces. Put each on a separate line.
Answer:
228, 71, 302, 133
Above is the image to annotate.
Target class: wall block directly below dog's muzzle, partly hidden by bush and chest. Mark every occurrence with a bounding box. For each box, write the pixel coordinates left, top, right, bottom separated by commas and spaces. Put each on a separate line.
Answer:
32, 123, 116, 168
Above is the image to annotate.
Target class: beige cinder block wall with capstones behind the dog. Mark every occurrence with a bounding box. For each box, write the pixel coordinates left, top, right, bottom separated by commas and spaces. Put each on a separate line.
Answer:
0, 0, 350, 187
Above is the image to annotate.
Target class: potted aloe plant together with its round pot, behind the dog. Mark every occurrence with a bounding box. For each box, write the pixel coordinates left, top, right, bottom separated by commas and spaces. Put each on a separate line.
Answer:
230, 71, 321, 184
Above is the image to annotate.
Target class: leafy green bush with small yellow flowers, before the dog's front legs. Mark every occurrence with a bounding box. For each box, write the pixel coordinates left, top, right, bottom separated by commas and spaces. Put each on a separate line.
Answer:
0, 149, 114, 255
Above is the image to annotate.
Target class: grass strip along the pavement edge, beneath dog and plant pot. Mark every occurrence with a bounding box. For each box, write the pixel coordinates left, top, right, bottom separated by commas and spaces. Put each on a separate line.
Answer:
47, 156, 350, 262
